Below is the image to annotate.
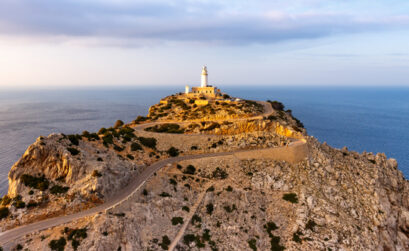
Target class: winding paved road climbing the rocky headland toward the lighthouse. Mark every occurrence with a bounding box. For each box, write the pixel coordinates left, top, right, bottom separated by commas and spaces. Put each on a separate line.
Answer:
0, 102, 300, 246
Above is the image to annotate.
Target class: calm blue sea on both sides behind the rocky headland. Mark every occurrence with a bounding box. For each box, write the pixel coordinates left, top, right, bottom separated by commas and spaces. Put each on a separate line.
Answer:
0, 86, 409, 196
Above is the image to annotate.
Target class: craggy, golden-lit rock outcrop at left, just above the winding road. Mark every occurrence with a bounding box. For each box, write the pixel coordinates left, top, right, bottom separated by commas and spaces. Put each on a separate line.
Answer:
2, 134, 144, 229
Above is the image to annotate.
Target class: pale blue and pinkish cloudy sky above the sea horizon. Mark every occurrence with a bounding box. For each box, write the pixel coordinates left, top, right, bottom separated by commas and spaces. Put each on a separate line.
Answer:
0, 0, 409, 89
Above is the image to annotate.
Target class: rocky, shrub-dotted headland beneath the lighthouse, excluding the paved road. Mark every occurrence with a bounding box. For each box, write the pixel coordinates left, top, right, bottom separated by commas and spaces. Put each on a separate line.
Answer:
0, 96, 409, 250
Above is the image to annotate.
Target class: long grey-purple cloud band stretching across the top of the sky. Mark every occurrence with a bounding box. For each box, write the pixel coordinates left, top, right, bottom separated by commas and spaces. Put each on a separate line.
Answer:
0, 0, 409, 46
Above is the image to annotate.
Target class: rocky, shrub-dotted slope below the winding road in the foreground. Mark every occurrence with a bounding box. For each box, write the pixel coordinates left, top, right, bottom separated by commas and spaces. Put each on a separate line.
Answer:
10, 137, 409, 250
